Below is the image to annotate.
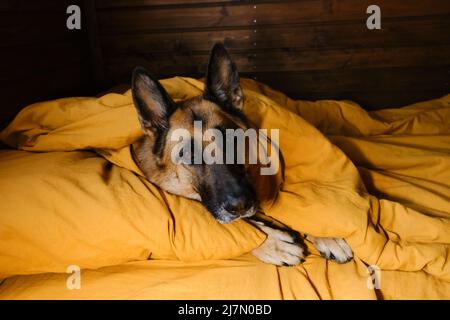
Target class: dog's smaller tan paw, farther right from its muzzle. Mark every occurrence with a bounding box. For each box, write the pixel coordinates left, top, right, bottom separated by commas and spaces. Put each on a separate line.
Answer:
308, 236, 353, 263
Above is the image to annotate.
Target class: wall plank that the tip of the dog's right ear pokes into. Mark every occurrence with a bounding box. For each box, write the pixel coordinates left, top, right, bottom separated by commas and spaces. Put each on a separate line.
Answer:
101, 16, 450, 55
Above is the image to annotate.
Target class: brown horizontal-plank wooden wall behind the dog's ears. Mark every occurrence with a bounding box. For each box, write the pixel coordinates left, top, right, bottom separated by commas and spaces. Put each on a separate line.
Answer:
96, 0, 450, 108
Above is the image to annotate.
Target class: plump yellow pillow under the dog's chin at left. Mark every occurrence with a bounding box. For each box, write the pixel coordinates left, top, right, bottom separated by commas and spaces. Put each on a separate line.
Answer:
0, 150, 265, 277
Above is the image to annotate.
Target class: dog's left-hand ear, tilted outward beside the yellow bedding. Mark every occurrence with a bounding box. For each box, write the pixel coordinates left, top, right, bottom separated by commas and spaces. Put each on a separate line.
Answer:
131, 67, 175, 133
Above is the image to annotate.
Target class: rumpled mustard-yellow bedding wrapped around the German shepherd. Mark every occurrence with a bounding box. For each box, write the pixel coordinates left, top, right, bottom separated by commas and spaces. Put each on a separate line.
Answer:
0, 77, 450, 299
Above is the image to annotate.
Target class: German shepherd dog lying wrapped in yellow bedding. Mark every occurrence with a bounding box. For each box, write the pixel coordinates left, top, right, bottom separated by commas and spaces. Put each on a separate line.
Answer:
132, 43, 353, 265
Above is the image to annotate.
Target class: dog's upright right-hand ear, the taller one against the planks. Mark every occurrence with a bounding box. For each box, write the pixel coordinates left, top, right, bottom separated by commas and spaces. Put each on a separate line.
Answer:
204, 43, 244, 110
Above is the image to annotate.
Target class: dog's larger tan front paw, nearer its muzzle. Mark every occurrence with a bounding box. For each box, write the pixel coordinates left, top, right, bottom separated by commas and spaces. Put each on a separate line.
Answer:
252, 225, 307, 266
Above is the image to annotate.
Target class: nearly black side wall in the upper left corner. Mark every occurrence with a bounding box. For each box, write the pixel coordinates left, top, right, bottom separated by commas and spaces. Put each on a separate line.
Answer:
0, 0, 95, 125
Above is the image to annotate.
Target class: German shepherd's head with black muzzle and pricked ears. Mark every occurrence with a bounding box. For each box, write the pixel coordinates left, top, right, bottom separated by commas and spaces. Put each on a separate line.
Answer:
132, 44, 258, 223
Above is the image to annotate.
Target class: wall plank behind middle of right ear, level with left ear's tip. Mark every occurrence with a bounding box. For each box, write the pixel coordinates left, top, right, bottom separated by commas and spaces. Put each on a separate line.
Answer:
101, 45, 450, 76
